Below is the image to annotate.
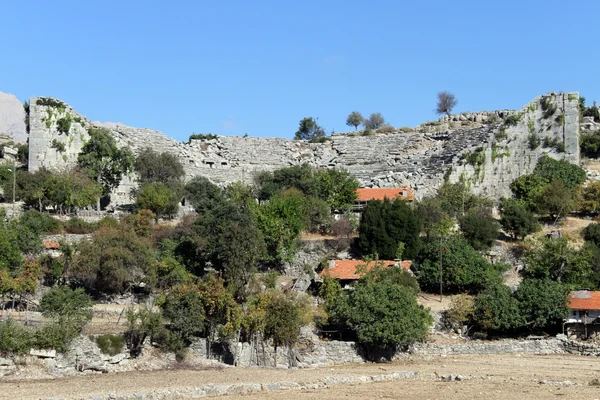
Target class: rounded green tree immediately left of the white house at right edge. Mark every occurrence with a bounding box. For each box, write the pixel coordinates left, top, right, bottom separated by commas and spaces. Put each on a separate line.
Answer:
515, 279, 570, 330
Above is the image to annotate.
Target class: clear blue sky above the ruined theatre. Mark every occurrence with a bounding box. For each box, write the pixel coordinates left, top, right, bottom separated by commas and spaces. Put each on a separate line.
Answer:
0, 0, 600, 140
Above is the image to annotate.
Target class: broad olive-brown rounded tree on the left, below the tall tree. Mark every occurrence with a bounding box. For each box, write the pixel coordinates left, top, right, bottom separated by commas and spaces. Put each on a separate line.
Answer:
70, 225, 156, 293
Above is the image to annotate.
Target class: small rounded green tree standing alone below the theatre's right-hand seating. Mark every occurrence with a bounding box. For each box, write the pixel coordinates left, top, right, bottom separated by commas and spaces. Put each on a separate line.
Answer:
459, 207, 500, 250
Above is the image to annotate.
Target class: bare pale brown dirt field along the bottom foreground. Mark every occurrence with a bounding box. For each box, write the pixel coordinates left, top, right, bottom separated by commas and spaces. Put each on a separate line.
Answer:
0, 355, 600, 400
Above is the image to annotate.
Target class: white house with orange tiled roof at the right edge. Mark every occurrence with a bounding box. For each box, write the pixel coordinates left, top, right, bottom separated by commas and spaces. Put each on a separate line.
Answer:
564, 290, 600, 338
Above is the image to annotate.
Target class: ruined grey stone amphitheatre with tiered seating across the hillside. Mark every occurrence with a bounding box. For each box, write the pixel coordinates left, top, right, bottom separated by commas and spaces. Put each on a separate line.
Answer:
29, 93, 579, 203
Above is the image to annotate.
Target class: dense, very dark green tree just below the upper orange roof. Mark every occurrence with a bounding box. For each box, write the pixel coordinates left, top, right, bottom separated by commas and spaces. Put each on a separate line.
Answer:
358, 199, 421, 259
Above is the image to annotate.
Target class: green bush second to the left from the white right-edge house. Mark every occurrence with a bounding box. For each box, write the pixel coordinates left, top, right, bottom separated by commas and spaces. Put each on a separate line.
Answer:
475, 284, 524, 331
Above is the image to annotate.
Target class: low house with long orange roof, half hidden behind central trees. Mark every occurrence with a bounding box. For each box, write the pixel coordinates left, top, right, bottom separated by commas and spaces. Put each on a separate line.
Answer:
319, 260, 412, 289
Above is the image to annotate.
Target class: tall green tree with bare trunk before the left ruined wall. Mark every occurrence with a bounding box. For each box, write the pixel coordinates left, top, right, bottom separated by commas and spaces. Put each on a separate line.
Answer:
77, 128, 135, 211
